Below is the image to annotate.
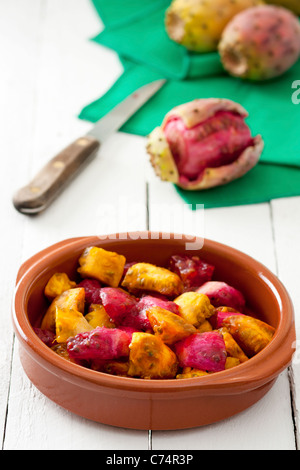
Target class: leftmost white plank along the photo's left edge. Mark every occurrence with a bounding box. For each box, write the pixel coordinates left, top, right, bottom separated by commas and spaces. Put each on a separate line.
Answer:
0, 0, 44, 445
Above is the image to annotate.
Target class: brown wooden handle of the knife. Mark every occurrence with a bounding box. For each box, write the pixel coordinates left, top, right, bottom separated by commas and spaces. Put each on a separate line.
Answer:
13, 136, 100, 214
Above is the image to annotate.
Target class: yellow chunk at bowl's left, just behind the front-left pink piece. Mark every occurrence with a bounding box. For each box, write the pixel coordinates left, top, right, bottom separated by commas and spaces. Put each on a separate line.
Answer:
55, 307, 94, 343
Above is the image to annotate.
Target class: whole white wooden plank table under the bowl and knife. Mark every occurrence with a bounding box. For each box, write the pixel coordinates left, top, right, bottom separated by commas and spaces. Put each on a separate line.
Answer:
0, 0, 300, 450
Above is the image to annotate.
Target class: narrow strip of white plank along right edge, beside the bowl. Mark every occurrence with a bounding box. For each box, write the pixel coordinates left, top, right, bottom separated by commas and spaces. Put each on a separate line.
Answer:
271, 197, 300, 449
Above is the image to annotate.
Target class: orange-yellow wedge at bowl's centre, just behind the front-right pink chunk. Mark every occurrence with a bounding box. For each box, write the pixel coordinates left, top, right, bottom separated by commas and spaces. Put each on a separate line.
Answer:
146, 307, 197, 345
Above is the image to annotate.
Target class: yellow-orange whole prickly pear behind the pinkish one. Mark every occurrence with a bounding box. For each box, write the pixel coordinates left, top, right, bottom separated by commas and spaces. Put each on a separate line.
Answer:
165, 0, 263, 52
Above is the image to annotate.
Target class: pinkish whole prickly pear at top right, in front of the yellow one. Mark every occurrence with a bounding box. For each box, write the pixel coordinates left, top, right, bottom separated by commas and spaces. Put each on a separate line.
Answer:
219, 5, 300, 80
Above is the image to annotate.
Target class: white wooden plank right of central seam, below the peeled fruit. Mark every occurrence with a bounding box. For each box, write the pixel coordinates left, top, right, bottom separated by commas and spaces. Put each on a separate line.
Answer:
148, 169, 295, 450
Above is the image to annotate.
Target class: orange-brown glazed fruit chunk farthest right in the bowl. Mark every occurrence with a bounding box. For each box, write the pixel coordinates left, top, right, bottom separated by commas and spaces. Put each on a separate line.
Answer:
223, 315, 275, 357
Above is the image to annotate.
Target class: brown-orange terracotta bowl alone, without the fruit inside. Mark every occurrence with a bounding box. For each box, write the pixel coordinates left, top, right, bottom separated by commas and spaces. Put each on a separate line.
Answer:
13, 232, 295, 430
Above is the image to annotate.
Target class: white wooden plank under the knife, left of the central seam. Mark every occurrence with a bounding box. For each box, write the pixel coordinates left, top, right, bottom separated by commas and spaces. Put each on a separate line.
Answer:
1, 0, 148, 450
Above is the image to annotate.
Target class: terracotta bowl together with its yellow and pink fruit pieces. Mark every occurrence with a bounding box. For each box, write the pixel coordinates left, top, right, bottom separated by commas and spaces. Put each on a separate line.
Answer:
12, 232, 295, 430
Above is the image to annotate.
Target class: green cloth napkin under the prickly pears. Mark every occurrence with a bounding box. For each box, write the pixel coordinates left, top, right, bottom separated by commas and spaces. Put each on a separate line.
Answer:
79, 0, 300, 208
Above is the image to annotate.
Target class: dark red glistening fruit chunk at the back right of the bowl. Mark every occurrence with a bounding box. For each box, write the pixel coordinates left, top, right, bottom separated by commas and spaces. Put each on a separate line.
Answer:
169, 255, 215, 291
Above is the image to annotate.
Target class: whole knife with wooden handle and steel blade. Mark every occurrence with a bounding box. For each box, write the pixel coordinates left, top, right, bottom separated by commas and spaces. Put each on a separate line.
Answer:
13, 80, 166, 215
